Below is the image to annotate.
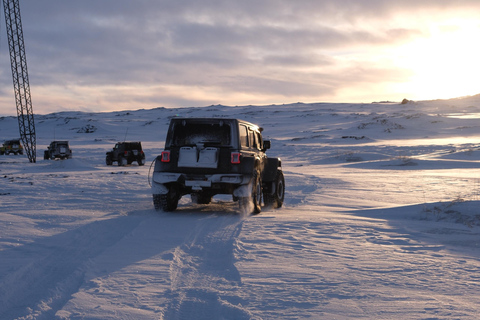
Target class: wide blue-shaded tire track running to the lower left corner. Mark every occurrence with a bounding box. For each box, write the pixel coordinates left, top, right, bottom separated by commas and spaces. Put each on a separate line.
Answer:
0, 216, 143, 319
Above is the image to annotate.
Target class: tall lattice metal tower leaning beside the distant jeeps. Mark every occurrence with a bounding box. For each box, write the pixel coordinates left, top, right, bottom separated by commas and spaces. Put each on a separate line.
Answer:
3, 0, 37, 163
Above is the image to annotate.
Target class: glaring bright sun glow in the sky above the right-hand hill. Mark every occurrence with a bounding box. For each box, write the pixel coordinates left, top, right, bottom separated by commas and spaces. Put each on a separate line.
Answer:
396, 21, 480, 99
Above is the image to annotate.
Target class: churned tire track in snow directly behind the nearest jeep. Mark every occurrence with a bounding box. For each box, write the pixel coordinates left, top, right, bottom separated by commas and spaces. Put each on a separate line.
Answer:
164, 215, 252, 320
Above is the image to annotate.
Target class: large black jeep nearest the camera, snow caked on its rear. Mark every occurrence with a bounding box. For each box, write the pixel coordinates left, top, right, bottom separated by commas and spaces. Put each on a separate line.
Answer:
152, 118, 285, 214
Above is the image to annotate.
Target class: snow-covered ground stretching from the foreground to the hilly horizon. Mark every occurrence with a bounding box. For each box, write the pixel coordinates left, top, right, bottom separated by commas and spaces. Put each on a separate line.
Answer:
0, 96, 480, 320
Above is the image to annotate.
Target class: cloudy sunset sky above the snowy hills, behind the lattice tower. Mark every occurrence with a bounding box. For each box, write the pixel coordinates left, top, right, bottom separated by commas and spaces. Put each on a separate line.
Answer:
0, 0, 480, 115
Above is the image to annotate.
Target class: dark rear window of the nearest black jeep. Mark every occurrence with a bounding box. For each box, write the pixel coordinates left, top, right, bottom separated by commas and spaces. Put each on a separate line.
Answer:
172, 122, 231, 146
